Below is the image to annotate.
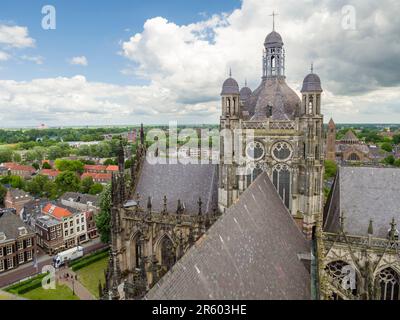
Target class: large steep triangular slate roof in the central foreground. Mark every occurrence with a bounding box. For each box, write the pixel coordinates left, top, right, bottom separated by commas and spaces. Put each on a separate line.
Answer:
145, 173, 311, 300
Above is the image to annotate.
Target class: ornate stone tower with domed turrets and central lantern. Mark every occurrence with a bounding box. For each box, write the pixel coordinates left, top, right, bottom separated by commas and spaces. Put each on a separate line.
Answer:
218, 25, 324, 237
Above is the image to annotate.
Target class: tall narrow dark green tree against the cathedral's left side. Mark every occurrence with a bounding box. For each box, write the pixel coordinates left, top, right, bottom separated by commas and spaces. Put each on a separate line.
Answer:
96, 184, 111, 243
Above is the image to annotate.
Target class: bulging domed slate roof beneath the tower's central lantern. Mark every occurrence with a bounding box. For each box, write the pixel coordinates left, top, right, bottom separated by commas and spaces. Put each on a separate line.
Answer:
248, 78, 301, 120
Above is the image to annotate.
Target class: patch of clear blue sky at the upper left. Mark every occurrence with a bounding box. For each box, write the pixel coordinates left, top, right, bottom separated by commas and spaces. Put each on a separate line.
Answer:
0, 0, 240, 84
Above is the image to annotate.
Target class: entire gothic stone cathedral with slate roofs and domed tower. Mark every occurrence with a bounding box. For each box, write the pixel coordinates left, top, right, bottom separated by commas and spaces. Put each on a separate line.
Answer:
99, 20, 400, 300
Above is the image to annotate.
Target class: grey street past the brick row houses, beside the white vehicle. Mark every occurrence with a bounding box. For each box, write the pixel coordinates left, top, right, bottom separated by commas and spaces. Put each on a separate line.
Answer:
0, 242, 107, 288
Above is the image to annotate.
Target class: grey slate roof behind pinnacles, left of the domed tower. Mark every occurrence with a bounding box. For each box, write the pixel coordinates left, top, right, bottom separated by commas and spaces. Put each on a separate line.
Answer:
135, 161, 218, 214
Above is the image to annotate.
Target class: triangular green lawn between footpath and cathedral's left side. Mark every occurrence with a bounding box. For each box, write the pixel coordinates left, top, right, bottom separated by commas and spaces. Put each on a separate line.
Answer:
76, 257, 109, 299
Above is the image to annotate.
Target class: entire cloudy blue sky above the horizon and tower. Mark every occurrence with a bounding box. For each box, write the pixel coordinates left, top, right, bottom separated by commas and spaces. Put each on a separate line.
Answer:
0, 0, 400, 127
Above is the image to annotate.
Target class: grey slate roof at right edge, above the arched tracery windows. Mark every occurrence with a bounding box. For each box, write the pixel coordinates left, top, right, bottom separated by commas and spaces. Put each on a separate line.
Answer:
324, 167, 400, 238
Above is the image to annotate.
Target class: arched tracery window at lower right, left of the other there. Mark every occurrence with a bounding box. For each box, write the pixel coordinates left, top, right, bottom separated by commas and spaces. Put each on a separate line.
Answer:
325, 260, 357, 295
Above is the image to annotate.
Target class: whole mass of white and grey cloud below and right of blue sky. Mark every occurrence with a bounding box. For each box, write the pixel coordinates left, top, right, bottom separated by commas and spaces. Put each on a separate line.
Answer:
0, 0, 400, 125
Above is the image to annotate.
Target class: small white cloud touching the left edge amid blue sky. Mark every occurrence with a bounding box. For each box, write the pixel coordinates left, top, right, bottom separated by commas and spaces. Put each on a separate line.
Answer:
0, 24, 35, 48
